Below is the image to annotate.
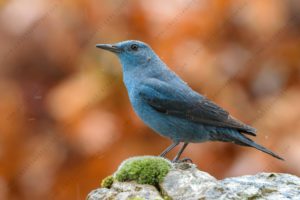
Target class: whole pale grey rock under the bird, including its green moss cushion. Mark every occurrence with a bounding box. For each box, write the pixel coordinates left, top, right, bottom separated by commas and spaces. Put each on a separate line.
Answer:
87, 156, 300, 200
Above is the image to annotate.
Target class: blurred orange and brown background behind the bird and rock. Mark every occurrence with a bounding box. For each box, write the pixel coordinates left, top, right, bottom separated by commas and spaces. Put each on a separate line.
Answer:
0, 0, 300, 200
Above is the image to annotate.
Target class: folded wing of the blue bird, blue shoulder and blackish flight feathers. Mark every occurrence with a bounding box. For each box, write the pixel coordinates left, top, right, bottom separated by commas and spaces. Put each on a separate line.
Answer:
139, 79, 256, 136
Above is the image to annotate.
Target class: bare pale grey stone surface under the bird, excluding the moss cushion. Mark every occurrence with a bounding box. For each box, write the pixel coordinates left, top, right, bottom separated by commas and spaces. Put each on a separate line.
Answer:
87, 163, 300, 200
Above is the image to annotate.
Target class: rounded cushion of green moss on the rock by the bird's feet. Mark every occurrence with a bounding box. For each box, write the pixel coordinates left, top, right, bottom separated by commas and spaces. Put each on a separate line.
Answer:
115, 156, 171, 186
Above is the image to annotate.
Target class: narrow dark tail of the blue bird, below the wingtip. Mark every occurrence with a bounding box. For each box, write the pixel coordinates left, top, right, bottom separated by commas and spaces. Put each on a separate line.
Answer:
232, 134, 284, 160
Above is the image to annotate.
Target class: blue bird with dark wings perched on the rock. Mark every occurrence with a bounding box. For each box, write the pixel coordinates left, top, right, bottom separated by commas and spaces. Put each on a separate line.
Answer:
96, 40, 283, 162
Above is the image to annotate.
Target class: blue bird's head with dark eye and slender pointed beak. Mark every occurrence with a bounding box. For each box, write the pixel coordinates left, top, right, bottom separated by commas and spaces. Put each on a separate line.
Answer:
96, 40, 156, 69
